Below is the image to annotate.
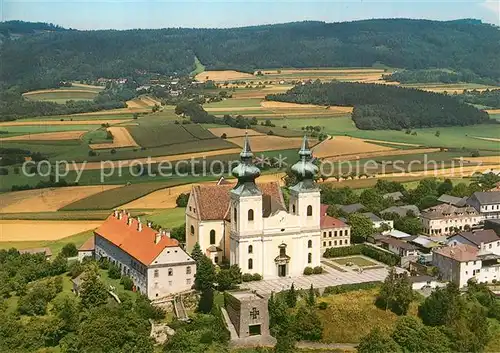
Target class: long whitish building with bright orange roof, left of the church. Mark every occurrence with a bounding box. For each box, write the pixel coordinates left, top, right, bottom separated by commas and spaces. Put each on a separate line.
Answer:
94, 211, 196, 299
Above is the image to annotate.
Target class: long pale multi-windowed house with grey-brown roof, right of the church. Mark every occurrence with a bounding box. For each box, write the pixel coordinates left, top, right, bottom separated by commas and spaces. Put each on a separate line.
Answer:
420, 204, 482, 235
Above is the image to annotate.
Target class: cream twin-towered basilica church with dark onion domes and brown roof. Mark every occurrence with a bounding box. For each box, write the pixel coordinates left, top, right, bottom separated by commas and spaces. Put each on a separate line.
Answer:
186, 136, 321, 279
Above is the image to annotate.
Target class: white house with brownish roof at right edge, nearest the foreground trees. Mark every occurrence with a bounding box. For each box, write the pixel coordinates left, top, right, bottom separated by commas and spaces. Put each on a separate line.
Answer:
432, 244, 500, 288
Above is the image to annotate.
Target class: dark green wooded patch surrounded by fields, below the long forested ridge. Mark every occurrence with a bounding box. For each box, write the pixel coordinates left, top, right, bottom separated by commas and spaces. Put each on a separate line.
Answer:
266, 82, 490, 130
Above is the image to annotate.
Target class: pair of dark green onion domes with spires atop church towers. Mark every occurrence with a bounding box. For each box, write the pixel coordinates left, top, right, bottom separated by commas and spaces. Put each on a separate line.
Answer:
232, 134, 318, 193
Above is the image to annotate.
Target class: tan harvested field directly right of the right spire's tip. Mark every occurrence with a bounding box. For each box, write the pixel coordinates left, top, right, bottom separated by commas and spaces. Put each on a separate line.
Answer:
312, 136, 393, 158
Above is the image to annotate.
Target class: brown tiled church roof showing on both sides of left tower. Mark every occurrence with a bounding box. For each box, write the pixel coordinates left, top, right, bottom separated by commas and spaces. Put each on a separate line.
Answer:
192, 182, 285, 221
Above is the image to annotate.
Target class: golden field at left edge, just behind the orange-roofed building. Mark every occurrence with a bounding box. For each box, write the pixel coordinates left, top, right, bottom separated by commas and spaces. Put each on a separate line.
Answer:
0, 220, 102, 242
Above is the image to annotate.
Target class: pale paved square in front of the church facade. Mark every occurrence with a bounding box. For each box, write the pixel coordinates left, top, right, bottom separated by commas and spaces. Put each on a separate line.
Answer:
245, 259, 406, 294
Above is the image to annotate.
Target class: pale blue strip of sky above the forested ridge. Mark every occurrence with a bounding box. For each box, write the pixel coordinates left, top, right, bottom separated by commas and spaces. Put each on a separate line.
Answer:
0, 0, 500, 30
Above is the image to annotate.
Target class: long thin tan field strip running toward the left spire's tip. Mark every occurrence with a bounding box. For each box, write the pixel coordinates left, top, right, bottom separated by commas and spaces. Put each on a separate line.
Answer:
68, 148, 241, 170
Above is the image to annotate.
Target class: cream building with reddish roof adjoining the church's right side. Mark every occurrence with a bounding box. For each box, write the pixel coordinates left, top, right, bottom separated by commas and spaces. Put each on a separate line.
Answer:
320, 204, 351, 253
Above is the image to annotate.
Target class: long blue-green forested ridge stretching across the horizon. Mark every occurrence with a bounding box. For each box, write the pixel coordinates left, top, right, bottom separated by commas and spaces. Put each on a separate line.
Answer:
0, 19, 500, 89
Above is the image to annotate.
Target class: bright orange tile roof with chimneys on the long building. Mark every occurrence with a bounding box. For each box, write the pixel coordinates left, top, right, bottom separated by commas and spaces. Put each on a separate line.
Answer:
95, 213, 179, 266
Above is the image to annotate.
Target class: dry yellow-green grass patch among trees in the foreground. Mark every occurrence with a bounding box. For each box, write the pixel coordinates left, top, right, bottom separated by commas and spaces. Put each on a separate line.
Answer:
318, 288, 417, 343
